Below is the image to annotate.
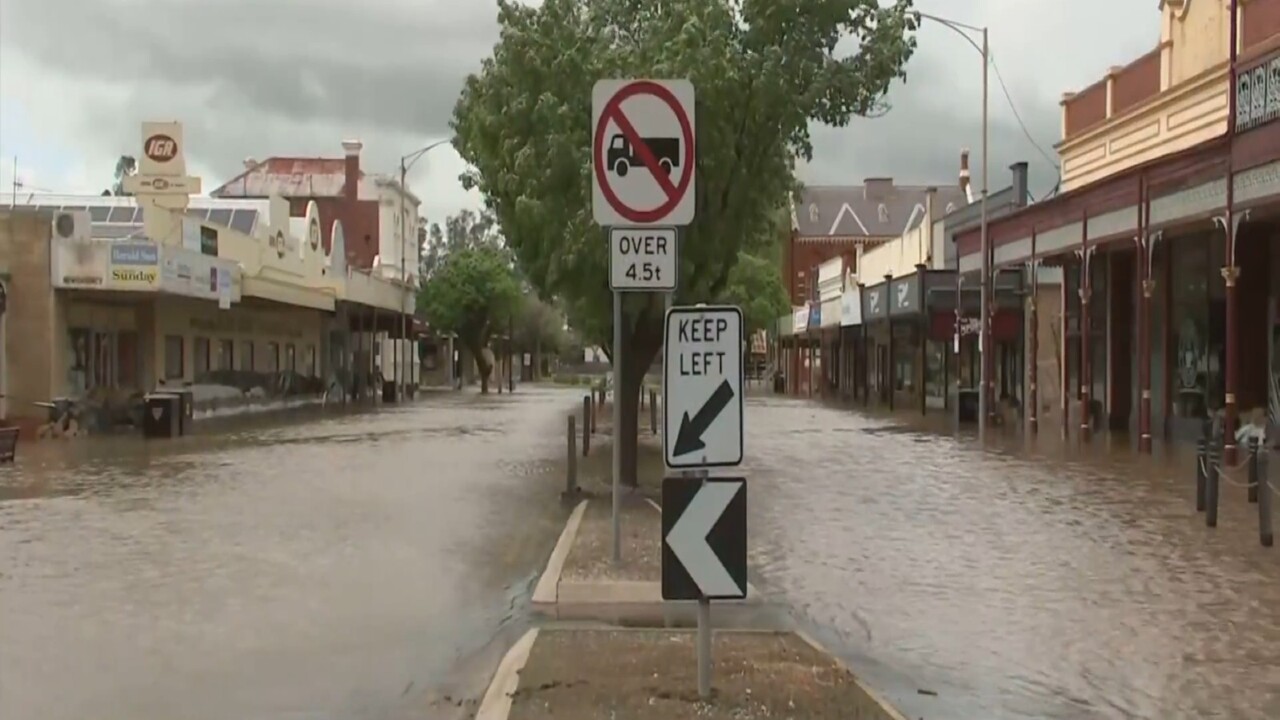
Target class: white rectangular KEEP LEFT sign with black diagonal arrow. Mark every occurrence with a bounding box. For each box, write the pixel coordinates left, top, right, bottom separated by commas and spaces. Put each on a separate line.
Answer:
662, 305, 742, 469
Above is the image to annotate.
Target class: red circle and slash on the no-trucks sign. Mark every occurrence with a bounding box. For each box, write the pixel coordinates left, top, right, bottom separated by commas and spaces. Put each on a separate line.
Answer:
591, 79, 694, 223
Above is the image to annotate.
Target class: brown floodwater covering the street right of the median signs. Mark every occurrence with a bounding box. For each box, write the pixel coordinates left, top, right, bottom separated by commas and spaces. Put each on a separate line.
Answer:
744, 398, 1280, 720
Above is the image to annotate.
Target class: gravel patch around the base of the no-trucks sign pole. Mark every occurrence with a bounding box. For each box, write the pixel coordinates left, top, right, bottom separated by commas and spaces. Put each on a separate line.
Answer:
561, 496, 662, 583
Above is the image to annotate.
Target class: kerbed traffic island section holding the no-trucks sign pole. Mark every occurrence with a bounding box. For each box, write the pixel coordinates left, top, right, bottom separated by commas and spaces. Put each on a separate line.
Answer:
534, 496, 780, 628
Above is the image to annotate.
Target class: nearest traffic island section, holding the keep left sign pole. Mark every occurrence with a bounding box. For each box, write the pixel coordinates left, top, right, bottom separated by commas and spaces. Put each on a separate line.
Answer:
476, 628, 905, 720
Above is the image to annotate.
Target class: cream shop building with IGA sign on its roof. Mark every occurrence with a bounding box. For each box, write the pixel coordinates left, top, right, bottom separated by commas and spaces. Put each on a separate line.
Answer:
0, 123, 412, 429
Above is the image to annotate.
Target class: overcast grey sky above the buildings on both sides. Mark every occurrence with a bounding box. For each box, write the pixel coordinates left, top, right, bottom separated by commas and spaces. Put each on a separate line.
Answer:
0, 0, 1160, 222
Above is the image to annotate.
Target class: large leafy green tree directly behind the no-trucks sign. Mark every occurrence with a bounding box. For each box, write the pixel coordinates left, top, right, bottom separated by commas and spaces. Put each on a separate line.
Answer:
453, 0, 915, 484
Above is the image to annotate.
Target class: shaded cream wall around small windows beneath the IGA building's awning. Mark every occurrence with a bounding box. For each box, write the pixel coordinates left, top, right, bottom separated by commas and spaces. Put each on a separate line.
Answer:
151, 297, 328, 382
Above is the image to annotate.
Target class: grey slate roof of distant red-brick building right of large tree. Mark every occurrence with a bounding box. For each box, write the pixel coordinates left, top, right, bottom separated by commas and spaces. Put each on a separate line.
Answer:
795, 181, 968, 238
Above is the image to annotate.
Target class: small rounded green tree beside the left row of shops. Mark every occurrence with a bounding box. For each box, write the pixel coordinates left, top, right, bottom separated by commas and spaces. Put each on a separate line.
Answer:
417, 211, 522, 393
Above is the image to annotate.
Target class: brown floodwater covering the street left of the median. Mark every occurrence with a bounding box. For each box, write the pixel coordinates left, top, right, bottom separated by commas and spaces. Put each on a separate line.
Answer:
0, 388, 580, 720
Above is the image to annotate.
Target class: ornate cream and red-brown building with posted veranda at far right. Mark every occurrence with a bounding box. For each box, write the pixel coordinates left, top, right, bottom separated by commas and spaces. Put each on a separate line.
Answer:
956, 0, 1280, 456
